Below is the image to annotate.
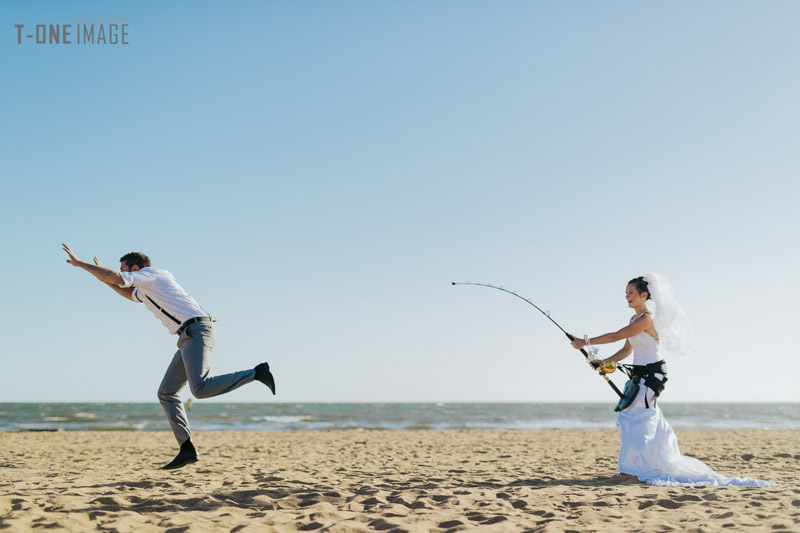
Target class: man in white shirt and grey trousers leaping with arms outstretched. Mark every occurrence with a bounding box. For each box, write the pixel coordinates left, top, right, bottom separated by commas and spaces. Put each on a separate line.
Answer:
62, 243, 275, 470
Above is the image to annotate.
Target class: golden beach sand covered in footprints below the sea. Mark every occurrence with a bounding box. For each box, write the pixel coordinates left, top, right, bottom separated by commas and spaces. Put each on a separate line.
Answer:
0, 430, 800, 533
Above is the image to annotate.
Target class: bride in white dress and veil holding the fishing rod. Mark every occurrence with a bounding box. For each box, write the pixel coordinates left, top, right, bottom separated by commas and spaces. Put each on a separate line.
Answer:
572, 273, 775, 487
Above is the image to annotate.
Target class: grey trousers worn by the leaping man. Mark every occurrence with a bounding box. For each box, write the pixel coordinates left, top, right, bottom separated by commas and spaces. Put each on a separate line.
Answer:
158, 322, 256, 444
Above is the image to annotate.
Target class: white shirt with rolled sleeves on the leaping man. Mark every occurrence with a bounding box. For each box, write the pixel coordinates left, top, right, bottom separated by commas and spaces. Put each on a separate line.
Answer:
119, 267, 208, 334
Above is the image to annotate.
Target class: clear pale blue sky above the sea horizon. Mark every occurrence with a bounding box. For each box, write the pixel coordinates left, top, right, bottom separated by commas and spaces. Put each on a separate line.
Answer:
0, 0, 800, 404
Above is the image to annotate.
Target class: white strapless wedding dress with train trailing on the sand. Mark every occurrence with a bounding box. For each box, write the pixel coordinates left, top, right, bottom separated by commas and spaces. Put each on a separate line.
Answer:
617, 332, 775, 487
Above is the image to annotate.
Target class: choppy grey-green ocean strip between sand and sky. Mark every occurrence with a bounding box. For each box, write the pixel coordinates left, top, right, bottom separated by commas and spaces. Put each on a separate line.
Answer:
0, 400, 800, 431
